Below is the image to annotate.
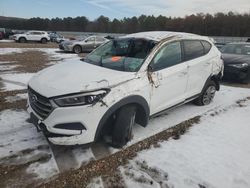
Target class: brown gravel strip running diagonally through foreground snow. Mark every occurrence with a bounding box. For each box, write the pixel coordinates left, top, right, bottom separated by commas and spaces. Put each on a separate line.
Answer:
40, 116, 200, 188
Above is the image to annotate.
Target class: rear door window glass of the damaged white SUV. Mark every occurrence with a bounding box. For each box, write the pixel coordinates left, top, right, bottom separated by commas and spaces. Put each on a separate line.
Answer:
183, 40, 204, 60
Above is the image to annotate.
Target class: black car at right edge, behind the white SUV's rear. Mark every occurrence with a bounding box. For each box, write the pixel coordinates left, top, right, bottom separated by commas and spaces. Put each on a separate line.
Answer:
221, 42, 250, 83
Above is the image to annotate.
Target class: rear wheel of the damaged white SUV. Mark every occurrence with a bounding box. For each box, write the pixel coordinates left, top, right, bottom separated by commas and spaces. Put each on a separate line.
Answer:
194, 80, 216, 106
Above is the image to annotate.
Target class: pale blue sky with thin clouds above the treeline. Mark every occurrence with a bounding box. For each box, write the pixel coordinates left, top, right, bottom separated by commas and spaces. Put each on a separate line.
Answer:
0, 0, 250, 20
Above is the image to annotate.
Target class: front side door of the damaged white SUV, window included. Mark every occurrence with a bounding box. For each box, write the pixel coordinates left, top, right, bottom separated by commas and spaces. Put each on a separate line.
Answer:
149, 41, 187, 114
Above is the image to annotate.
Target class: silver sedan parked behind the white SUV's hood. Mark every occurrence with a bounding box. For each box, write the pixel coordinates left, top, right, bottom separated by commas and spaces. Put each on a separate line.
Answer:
59, 35, 109, 54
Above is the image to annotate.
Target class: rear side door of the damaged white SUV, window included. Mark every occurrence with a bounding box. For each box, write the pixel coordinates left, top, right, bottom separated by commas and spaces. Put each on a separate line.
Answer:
183, 40, 212, 98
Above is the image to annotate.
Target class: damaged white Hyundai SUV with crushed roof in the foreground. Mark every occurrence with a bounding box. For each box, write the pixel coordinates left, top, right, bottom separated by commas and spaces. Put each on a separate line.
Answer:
28, 31, 223, 147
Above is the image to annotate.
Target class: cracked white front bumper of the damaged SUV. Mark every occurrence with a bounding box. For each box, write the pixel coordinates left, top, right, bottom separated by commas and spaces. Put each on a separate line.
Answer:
27, 97, 107, 145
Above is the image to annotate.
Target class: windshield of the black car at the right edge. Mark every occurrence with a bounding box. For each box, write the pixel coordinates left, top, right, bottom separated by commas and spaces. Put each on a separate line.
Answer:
221, 44, 250, 55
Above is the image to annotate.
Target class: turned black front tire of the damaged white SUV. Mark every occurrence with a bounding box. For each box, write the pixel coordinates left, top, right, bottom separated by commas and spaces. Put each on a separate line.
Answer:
112, 105, 136, 148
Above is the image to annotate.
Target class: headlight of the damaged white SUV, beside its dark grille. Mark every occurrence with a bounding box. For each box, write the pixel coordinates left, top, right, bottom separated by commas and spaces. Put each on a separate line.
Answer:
54, 90, 109, 107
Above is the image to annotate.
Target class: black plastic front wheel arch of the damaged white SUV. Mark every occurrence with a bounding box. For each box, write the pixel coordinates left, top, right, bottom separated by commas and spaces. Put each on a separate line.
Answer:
95, 95, 150, 141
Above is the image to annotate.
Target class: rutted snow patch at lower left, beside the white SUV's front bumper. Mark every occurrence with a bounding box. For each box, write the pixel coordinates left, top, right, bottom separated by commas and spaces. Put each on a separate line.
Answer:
0, 110, 59, 178
